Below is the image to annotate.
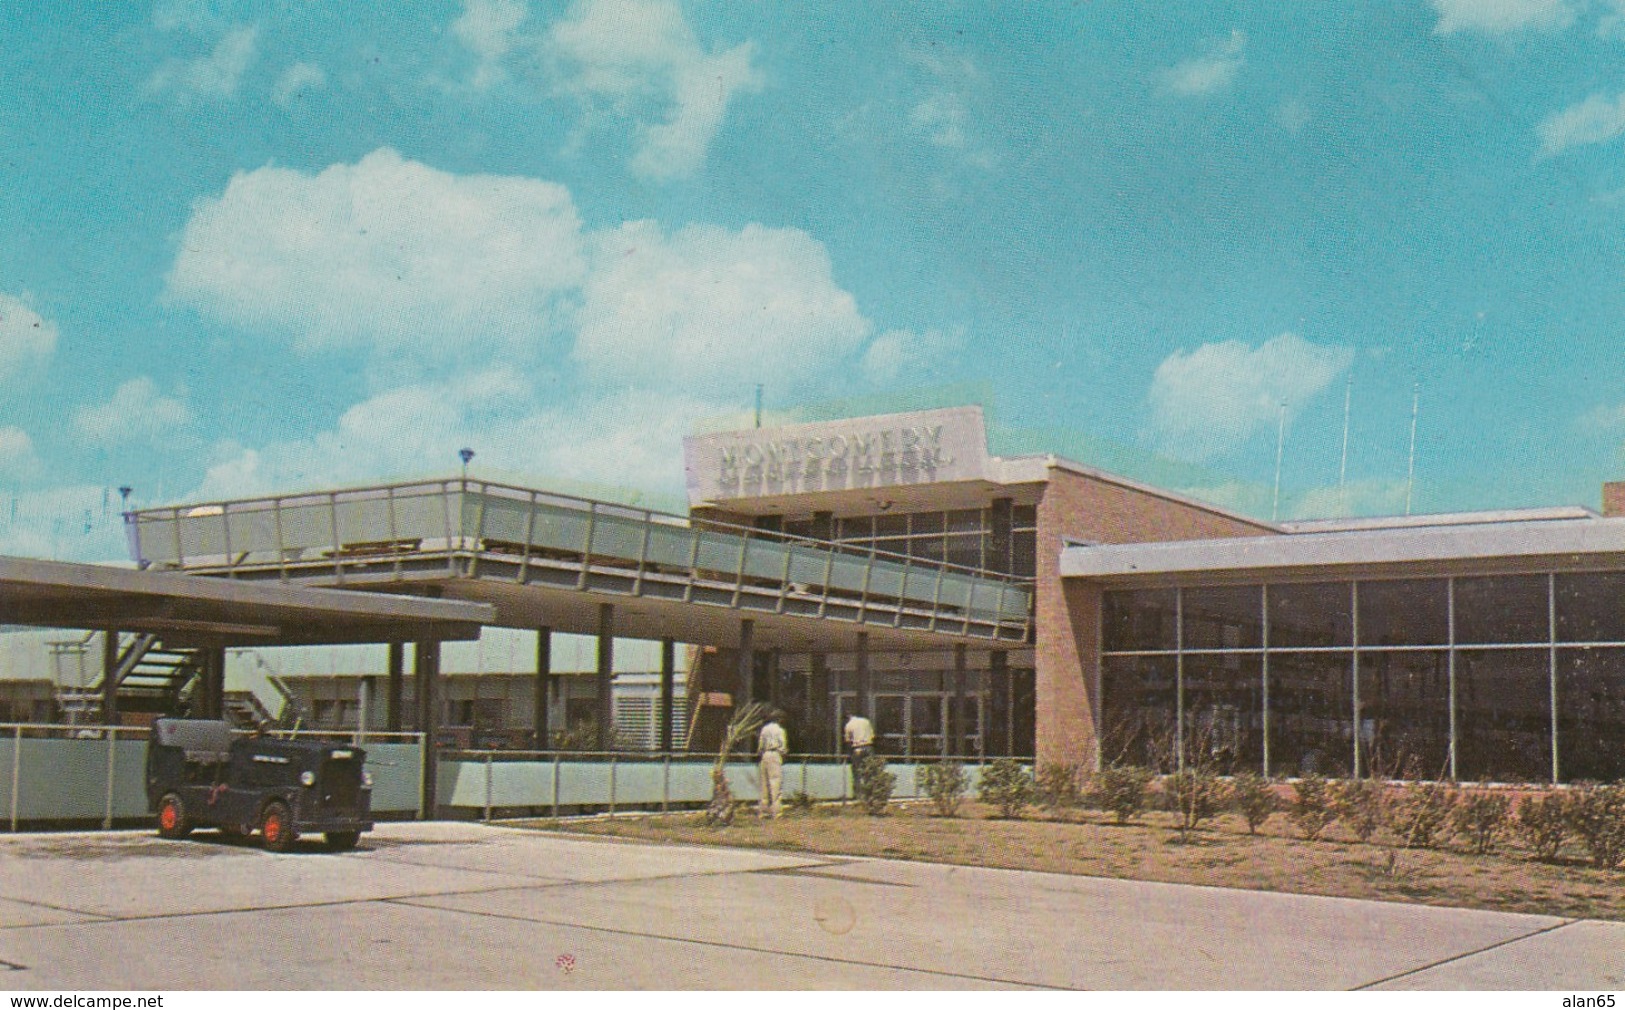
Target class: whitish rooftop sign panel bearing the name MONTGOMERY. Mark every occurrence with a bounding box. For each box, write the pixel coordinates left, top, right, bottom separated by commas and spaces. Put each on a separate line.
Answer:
683, 408, 988, 505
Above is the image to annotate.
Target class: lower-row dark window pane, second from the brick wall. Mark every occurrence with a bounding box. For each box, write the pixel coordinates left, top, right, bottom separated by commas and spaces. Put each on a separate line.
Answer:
1185, 656, 1264, 775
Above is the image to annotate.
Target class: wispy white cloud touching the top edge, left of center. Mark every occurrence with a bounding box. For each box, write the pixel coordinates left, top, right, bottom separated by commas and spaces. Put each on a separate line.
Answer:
543, 0, 762, 179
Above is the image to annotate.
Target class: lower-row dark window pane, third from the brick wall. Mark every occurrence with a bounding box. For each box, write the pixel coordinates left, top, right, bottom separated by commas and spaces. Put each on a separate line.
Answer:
1269, 653, 1354, 776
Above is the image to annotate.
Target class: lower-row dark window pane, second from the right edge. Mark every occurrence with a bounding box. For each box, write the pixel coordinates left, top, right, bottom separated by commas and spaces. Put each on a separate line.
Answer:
1456, 650, 1552, 783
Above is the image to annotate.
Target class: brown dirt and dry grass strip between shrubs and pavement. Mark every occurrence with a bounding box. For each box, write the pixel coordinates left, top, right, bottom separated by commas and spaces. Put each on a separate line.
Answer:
518, 802, 1625, 921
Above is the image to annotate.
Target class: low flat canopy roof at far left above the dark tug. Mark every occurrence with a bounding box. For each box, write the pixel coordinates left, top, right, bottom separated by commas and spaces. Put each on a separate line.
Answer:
0, 557, 496, 645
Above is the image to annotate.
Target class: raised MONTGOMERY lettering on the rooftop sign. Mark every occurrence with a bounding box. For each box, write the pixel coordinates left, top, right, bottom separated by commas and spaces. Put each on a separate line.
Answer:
718, 424, 954, 487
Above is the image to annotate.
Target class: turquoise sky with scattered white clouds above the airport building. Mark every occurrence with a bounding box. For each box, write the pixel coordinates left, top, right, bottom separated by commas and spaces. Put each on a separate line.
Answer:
0, 0, 1625, 559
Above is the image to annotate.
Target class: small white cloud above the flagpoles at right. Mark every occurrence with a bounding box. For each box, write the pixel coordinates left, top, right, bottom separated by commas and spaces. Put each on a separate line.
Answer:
1149, 333, 1354, 460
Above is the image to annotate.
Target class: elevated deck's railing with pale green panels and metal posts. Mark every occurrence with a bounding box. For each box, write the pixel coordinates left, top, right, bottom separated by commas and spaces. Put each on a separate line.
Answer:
127, 479, 1034, 641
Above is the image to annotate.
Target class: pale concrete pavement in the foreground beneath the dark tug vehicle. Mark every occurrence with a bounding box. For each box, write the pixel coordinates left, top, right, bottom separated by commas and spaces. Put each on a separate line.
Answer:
0, 823, 1625, 991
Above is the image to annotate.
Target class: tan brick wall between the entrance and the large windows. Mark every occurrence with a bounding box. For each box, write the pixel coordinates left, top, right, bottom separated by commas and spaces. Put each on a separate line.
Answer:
1034, 468, 1269, 765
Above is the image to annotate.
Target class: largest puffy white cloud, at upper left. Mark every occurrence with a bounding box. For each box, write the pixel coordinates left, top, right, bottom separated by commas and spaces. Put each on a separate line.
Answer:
166, 148, 585, 368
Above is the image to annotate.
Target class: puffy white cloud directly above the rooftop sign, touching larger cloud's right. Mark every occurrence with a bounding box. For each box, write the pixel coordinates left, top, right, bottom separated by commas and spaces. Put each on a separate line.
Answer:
575, 221, 871, 385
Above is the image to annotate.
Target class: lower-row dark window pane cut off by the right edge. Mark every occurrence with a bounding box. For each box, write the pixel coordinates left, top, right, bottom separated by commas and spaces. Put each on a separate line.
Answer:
1557, 650, 1625, 783
